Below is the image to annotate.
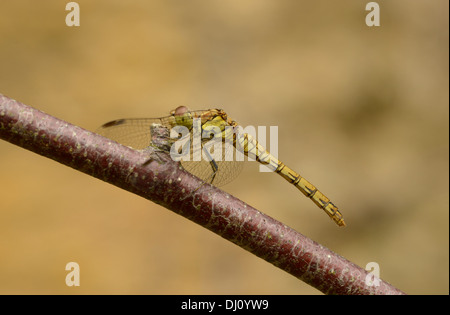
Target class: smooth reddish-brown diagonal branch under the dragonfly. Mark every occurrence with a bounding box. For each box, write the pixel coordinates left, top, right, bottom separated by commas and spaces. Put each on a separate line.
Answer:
0, 94, 404, 294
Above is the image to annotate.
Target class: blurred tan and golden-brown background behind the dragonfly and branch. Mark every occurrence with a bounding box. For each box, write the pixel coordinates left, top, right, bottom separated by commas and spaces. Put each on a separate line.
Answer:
0, 0, 449, 294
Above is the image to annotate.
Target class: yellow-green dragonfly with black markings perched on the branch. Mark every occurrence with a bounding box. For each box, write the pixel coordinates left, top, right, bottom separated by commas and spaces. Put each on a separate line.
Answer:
96, 106, 345, 226
